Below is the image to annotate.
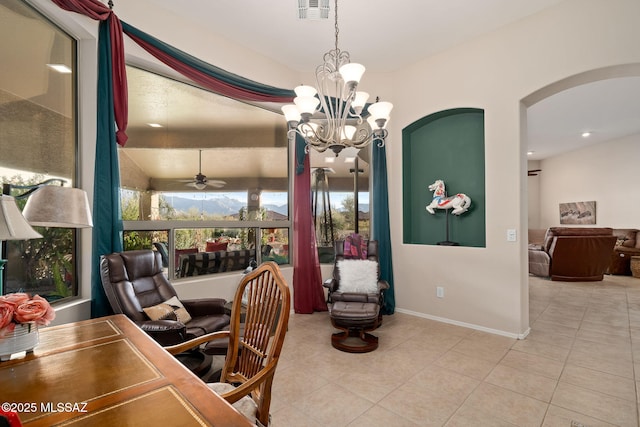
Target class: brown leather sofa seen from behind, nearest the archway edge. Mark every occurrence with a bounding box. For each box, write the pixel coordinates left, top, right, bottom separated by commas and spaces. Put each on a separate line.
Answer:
529, 227, 617, 282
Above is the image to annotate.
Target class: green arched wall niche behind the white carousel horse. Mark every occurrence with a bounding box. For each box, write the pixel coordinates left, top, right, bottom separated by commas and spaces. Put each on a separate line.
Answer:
402, 108, 486, 247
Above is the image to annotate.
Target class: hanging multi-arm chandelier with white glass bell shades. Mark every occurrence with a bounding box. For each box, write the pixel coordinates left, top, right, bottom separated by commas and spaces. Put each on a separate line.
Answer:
282, 0, 393, 157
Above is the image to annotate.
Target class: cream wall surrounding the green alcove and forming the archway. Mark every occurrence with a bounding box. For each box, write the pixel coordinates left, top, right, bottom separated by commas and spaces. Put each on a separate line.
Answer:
387, 0, 640, 336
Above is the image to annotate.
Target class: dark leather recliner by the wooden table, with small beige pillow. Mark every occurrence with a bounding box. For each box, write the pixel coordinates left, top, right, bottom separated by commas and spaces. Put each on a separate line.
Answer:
100, 250, 230, 346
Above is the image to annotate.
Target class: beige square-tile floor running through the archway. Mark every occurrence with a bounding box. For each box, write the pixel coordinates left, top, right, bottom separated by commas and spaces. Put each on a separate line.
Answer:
271, 276, 640, 427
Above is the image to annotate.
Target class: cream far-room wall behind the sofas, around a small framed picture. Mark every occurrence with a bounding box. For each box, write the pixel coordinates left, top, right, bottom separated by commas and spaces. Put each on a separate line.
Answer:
539, 134, 640, 228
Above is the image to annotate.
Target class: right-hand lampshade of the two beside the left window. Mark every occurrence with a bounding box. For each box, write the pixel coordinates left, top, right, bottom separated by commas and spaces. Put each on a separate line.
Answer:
23, 185, 93, 228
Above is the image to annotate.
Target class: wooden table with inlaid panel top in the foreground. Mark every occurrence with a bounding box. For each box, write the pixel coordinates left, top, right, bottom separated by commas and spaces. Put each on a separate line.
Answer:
0, 315, 251, 427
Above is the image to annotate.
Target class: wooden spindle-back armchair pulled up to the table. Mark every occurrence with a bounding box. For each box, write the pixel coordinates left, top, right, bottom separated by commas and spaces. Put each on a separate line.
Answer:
165, 262, 291, 426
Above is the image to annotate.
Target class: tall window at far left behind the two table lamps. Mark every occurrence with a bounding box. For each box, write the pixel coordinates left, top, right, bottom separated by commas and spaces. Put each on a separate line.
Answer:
0, 0, 78, 301
